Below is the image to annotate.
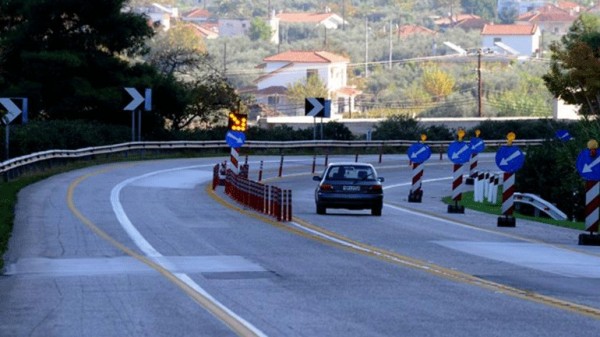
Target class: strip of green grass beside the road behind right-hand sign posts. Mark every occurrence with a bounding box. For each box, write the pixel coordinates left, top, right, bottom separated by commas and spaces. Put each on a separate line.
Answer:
442, 188, 585, 230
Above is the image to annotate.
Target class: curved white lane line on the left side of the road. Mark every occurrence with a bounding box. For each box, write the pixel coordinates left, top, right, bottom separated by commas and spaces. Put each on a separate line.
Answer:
110, 164, 266, 337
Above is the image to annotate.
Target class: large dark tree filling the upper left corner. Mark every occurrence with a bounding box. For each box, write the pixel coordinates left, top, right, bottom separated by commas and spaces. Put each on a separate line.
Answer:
0, 0, 156, 123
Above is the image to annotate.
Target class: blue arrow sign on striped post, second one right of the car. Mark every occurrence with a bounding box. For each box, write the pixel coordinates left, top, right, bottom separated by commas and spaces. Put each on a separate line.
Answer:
448, 129, 471, 213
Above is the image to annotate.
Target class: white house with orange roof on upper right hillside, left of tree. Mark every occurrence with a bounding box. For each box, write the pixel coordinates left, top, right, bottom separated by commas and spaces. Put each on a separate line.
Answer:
481, 24, 541, 57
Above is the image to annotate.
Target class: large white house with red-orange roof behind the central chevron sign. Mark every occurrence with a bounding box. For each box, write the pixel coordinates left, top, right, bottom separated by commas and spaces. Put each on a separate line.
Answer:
254, 51, 361, 118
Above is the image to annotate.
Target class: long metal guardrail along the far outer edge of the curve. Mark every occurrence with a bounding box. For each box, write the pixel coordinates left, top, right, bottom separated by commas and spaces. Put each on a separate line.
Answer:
0, 139, 544, 181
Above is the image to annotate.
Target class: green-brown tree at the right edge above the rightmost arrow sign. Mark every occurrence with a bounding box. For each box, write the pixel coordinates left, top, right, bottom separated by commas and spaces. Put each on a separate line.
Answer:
543, 13, 600, 116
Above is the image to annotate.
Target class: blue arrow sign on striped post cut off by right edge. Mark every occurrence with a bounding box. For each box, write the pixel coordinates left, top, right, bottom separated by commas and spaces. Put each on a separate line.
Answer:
576, 139, 600, 246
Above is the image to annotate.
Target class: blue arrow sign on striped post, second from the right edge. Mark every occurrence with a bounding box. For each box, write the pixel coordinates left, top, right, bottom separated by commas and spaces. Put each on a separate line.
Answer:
496, 132, 525, 227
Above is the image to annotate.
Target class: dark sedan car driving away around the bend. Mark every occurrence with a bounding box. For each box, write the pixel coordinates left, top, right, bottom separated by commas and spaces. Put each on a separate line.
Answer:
313, 163, 384, 216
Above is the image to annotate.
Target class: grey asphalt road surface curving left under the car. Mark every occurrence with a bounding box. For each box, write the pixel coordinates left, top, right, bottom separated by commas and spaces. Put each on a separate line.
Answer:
0, 155, 600, 337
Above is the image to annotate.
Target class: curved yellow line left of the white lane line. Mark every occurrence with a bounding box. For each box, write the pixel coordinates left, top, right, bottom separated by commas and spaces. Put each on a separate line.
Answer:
67, 169, 262, 337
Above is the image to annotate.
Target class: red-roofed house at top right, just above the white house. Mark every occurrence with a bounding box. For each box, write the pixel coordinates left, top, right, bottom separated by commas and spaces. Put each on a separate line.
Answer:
516, 4, 579, 35
